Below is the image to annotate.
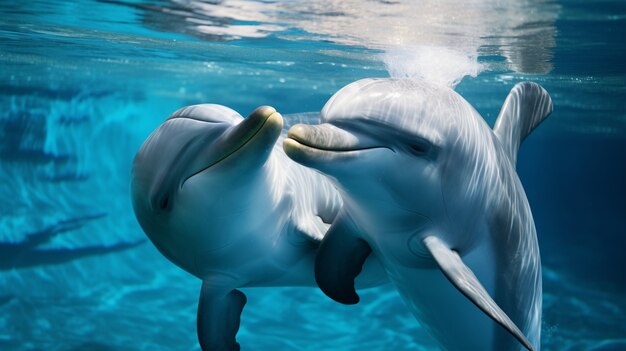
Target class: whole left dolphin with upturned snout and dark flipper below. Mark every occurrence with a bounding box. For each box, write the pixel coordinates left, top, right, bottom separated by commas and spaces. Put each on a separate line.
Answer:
131, 104, 388, 350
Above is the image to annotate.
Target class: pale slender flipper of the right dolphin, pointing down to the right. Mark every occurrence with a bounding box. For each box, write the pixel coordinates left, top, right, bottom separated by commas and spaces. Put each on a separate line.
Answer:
424, 236, 534, 351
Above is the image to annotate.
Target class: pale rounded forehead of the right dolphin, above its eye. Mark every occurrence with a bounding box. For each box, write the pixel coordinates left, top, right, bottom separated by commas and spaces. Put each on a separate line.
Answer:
321, 78, 474, 145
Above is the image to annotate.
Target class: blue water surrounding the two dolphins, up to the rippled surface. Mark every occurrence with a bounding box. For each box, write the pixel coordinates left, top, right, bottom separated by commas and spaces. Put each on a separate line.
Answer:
0, 0, 626, 350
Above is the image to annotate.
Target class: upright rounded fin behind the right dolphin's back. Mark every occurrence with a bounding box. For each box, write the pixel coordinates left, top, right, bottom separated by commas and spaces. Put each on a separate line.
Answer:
493, 82, 552, 166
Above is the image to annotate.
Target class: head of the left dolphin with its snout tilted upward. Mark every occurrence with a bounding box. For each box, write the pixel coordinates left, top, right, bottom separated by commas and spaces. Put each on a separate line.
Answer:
131, 104, 283, 275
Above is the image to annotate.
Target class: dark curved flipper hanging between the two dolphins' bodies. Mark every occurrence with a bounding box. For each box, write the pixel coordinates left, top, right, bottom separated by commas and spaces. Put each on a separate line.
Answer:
315, 218, 372, 305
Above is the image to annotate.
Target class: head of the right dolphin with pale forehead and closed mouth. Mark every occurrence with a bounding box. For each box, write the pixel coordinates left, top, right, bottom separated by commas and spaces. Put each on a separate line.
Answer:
283, 79, 492, 245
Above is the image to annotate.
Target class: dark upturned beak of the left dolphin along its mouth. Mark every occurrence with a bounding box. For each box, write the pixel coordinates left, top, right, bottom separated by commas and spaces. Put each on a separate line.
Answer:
181, 106, 283, 188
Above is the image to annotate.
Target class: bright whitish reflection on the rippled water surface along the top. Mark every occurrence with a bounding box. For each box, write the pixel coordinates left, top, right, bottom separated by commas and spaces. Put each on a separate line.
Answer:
114, 0, 560, 74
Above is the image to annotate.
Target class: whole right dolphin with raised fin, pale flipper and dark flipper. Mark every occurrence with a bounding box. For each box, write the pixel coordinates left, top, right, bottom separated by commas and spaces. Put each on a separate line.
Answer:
283, 79, 552, 351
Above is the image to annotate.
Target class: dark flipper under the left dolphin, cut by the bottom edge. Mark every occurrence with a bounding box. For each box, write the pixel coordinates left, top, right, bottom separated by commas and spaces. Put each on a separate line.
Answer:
197, 281, 246, 351
